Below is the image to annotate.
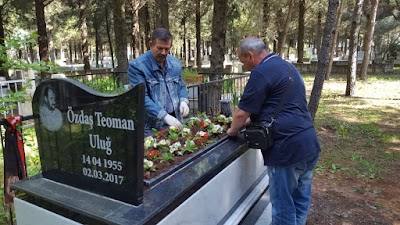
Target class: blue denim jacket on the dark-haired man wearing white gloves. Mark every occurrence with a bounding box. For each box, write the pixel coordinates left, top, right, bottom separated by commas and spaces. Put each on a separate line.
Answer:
128, 50, 189, 130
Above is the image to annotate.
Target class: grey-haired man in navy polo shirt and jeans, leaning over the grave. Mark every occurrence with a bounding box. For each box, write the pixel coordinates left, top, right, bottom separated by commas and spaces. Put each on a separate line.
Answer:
227, 37, 321, 225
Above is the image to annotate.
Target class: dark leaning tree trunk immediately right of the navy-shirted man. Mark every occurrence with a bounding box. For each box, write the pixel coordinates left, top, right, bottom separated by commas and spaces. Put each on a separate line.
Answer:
308, 0, 339, 120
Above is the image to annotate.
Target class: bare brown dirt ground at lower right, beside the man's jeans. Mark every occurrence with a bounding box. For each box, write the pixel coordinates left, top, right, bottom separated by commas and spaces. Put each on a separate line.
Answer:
307, 125, 400, 225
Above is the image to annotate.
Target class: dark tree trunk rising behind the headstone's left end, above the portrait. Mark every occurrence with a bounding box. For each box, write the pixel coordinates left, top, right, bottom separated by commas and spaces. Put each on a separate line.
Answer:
35, 0, 50, 78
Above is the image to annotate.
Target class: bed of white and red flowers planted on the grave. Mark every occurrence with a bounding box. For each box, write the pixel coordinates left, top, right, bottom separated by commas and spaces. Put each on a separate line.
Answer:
144, 114, 232, 180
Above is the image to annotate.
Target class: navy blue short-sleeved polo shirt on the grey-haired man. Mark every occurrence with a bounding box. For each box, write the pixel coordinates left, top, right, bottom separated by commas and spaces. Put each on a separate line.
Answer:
239, 53, 321, 166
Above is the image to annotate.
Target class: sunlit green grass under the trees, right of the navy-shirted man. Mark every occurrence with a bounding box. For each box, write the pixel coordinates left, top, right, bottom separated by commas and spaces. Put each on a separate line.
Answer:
305, 75, 400, 179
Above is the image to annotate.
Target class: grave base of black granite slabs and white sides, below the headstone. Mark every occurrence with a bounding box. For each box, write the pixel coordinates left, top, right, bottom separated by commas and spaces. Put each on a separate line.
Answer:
14, 139, 268, 225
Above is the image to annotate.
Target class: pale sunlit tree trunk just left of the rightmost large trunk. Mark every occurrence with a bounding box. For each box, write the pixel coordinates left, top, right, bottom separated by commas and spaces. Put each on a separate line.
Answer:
346, 0, 364, 96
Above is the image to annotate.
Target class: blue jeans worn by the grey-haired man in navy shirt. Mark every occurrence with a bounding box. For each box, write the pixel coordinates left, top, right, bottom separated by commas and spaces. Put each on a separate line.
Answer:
268, 153, 319, 225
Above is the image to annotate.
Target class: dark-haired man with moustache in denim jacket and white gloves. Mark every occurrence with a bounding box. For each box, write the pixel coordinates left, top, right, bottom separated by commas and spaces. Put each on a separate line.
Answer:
128, 28, 189, 131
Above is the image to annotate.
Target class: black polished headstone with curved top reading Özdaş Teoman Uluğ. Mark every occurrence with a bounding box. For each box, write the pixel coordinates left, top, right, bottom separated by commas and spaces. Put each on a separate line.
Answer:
32, 78, 144, 205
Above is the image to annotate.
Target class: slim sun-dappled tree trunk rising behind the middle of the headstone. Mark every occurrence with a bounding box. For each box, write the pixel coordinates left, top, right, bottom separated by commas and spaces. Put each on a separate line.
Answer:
79, 1, 90, 74
